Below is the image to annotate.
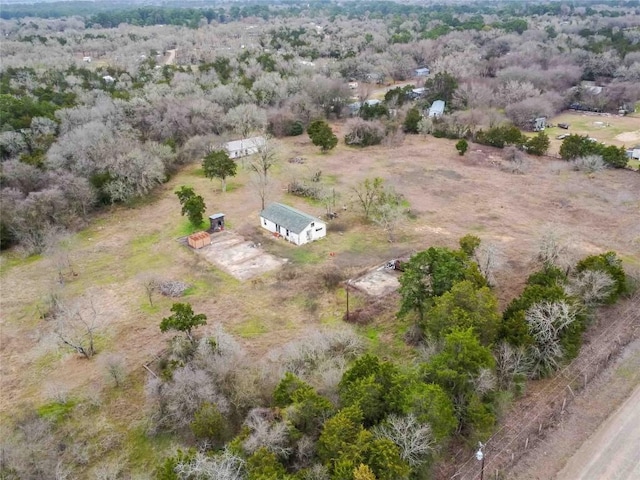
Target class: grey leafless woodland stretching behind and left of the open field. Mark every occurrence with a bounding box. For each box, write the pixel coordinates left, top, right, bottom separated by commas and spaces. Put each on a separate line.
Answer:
0, 3, 640, 251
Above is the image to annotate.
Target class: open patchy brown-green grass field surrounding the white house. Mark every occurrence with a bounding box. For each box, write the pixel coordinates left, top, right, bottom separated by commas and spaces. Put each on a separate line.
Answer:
0, 121, 640, 478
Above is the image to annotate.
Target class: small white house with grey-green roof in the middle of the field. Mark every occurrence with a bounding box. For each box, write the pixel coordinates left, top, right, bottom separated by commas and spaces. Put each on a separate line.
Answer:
260, 203, 327, 245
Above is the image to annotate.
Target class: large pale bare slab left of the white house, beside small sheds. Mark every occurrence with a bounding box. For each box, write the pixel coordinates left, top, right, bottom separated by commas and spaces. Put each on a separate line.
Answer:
194, 230, 284, 280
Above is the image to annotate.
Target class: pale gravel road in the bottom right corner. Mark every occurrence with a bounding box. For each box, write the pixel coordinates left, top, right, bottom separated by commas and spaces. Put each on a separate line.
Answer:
556, 382, 640, 480
